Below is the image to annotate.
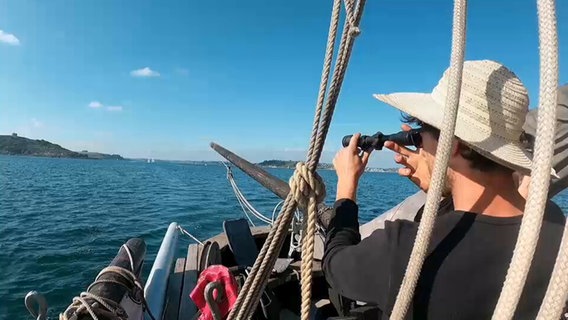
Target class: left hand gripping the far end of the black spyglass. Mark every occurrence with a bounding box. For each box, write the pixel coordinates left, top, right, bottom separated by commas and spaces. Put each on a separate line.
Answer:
333, 133, 371, 201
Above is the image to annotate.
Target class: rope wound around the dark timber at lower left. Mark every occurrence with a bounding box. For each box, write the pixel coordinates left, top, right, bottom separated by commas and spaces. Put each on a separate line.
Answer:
59, 245, 156, 320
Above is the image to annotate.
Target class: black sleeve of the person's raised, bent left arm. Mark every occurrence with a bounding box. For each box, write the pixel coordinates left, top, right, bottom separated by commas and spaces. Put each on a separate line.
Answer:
323, 199, 397, 310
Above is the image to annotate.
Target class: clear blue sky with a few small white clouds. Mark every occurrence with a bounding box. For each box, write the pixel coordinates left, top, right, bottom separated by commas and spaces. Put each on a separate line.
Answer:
0, 0, 568, 167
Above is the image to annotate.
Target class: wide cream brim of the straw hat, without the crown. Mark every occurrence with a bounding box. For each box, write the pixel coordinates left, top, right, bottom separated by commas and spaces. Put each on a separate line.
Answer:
373, 92, 556, 176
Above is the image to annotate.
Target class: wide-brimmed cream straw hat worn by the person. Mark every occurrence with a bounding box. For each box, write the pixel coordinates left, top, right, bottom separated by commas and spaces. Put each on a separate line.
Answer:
374, 60, 544, 173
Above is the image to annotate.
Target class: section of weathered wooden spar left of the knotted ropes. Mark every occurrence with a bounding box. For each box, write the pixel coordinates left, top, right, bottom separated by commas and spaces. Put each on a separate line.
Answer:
210, 142, 296, 200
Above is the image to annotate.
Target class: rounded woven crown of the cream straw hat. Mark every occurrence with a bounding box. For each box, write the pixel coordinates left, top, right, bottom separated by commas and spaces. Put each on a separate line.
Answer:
432, 60, 529, 142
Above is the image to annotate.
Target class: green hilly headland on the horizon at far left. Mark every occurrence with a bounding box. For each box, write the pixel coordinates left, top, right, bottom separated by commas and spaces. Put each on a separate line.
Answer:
0, 133, 124, 160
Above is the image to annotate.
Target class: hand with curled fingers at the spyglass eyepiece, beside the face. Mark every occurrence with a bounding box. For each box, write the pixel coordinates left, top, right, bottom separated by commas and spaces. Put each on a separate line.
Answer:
384, 124, 432, 192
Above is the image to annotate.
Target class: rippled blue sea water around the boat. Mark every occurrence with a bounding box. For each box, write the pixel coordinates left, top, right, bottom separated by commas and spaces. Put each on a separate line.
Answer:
0, 156, 568, 319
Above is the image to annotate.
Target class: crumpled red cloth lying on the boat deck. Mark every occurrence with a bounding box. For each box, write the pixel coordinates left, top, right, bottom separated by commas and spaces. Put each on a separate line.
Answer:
189, 265, 238, 320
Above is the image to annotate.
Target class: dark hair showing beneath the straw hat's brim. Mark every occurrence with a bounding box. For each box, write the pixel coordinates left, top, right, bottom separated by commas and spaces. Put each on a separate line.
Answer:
401, 113, 514, 174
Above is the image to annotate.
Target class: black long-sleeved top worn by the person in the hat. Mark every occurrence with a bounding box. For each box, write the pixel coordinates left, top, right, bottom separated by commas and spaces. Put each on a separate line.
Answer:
323, 199, 566, 319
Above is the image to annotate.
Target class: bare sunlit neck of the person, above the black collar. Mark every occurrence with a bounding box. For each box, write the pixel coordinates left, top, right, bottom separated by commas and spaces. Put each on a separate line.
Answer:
451, 172, 525, 217
